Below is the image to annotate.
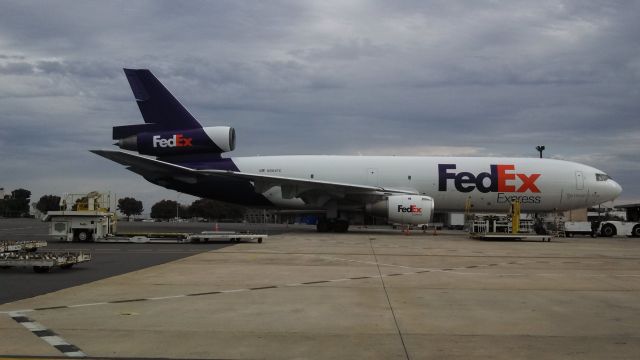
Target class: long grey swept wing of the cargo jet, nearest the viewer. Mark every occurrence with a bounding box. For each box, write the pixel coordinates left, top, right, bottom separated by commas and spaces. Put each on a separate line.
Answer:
91, 150, 417, 204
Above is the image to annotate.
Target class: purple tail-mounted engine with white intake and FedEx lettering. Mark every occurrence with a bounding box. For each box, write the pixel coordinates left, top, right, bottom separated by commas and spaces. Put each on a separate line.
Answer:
117, 126, 236, 156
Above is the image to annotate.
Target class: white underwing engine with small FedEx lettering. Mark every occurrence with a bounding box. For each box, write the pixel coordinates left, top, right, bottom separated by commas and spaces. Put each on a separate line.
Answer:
367, 195, 434, 225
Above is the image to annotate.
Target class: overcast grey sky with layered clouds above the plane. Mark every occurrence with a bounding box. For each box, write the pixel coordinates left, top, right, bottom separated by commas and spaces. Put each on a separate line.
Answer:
0, 0, 640, 210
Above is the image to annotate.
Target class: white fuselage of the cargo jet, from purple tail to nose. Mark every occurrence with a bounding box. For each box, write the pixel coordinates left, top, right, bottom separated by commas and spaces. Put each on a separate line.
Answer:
232, 155, 621, 212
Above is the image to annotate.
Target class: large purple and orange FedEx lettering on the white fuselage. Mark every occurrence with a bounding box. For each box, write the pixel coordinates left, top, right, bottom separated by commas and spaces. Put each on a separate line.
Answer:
438, 164, 541, 193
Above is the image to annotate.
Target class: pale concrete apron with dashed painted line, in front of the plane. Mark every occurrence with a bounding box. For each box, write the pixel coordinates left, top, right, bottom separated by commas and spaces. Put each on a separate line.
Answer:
0, 218, 640, 359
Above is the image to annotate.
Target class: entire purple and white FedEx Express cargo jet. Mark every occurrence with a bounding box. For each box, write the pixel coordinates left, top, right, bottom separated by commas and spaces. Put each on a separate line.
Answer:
92, 69, 622, 232
